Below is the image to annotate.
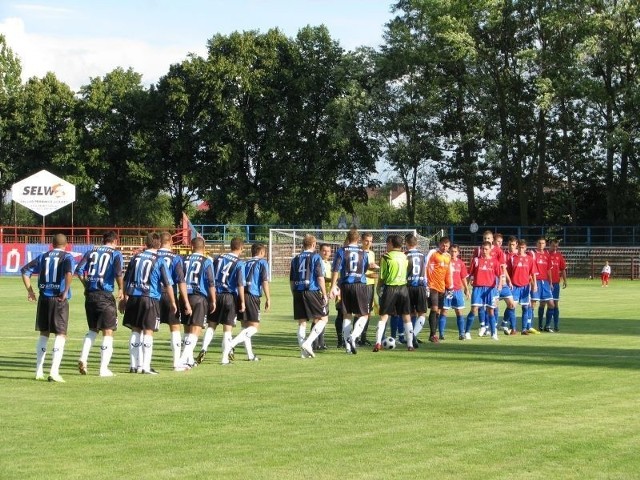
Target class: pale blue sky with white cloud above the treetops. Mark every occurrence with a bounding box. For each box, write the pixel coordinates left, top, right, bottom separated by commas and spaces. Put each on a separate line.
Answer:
0, 0, 393, 90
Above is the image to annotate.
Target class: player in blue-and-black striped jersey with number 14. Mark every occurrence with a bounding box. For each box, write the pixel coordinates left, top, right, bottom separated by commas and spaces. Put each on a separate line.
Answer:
196, 237, 245, 363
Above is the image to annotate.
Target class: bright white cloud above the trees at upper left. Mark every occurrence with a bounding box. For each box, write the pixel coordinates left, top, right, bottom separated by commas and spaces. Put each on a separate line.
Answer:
0, 17, 206, 91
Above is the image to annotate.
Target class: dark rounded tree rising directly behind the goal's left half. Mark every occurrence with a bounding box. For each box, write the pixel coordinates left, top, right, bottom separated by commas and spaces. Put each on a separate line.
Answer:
279, 26, 376, 225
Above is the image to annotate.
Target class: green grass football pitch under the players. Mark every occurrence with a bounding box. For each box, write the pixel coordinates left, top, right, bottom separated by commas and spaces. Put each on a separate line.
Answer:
0, 277, 640, 480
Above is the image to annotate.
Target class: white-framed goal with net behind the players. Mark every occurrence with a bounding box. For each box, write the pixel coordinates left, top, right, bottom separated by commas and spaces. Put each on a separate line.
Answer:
269, 228, 444, 277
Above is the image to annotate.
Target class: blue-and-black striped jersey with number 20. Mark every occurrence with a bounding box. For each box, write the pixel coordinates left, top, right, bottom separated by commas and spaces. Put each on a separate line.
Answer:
76, 245, 124, 292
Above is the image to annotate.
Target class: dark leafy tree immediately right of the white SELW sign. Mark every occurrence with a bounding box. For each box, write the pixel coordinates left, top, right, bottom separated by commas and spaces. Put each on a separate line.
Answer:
78, 68, 161, 225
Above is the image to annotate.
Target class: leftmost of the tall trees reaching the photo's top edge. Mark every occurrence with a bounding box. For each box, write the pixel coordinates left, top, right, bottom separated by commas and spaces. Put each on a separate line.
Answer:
382, 0, 500, 223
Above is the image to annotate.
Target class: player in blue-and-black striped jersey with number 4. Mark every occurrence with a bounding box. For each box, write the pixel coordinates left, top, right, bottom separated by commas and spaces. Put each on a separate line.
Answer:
289, 235, 329, 358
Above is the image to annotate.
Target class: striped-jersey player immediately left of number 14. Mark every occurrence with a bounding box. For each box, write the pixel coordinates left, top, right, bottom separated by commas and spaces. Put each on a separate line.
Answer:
174, 237, 216, 371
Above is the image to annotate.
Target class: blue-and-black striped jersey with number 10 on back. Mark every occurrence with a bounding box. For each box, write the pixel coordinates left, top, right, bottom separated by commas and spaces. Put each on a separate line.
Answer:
124, 250, 173, 300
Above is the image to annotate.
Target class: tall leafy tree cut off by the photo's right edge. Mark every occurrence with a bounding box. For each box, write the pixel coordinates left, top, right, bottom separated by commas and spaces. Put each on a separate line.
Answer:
579, 0, 640, 224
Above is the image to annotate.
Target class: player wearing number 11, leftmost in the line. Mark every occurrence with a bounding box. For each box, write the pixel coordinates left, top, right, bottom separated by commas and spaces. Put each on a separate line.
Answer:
20, 233, 74, 382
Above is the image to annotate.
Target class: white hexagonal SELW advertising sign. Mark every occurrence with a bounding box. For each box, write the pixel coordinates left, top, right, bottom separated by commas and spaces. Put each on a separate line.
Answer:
11, 170, 76, 216
